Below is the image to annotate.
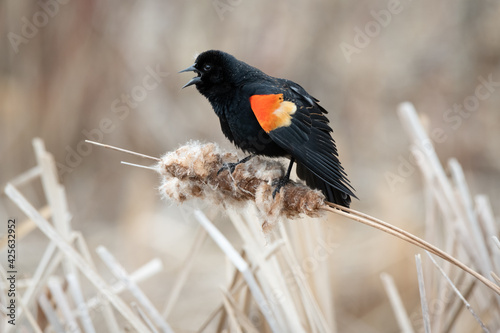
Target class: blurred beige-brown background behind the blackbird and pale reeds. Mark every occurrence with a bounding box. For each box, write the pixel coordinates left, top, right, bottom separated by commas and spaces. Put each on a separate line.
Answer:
0, 0, 500, 332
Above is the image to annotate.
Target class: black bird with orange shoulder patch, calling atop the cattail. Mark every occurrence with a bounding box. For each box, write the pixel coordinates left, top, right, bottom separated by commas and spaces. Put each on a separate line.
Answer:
179, 50, 356, 207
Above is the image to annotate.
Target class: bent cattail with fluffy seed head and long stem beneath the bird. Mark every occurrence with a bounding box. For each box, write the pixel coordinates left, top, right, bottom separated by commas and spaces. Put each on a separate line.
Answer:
86, 137, 500, 295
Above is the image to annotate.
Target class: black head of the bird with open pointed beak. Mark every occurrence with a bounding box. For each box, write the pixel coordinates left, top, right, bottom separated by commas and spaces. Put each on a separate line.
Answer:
179, 50, 241, 97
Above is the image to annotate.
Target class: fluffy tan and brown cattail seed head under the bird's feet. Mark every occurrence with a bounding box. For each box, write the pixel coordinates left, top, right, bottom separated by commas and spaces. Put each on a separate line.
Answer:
157, 142, 324, 230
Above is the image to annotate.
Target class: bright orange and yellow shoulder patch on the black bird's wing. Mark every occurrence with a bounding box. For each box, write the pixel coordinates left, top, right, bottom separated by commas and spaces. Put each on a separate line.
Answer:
250, 94, 297, 133
